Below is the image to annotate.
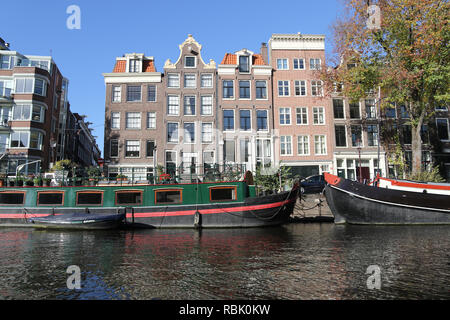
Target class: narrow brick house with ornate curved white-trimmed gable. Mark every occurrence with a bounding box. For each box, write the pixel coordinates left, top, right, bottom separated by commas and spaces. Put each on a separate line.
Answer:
160, 34, 218, 175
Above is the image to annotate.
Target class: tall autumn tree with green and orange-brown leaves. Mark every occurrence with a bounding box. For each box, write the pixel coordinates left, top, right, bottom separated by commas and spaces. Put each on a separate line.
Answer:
322, 0, 450, 174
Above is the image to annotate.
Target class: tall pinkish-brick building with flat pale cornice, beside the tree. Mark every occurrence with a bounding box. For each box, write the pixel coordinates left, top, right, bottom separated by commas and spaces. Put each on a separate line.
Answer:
269, 33, 334, 177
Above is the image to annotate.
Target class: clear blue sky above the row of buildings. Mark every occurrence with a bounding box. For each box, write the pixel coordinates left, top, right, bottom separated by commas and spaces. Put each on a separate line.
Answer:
0, 0, 342, 155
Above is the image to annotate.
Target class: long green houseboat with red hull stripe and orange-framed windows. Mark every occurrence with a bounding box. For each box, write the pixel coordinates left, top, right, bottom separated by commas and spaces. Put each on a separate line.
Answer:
0, 170, 298, 228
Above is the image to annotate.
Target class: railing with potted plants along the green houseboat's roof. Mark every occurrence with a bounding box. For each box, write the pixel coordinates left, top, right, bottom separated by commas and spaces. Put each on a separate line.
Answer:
0, 163, 246, 187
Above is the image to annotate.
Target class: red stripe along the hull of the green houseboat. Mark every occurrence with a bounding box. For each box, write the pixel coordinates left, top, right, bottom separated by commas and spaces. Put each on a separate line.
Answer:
0, 198, 295, 219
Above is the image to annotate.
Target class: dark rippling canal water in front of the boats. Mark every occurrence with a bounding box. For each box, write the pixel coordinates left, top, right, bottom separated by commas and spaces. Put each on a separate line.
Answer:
0, 223, 450, 300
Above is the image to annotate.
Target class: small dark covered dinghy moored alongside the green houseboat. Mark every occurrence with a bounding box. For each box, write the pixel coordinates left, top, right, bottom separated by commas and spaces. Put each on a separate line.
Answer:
28, 212, 125, 229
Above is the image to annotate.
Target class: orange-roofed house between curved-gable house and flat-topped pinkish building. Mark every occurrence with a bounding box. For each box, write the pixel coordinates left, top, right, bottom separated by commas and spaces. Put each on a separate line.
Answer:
217, 43, 275, 171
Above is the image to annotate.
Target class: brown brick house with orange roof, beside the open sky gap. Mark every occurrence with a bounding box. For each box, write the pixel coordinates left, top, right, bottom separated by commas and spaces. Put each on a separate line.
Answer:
103, 53, 166, 180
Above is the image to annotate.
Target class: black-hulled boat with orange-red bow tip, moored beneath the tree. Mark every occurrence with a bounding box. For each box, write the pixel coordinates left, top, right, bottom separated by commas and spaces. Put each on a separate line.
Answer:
324, 173, 450, 224
